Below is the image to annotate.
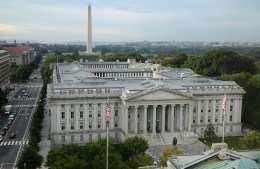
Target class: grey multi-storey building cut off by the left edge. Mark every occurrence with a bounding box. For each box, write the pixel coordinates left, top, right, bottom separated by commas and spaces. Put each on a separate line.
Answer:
0, 50, 10, 89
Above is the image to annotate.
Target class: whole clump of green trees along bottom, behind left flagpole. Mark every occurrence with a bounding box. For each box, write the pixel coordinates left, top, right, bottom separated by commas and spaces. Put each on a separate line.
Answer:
46, 136, 152, 169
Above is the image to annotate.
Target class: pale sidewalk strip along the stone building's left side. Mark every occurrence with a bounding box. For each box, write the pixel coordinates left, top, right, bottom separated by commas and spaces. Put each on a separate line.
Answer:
39, 107, 51, 168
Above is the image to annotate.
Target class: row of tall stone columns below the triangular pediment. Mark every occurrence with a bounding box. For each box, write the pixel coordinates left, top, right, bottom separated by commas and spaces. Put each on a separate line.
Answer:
122, 104, 193, 134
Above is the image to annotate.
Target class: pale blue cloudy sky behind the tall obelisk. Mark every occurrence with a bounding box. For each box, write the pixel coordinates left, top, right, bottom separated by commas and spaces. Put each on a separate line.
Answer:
0, 0, 260, 42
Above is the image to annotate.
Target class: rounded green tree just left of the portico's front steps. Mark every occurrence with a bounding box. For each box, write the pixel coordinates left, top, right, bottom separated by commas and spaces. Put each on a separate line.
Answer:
120, 136, 148, 160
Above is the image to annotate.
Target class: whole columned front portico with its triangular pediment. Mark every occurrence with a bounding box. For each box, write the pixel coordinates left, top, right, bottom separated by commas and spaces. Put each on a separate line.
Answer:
122, 88, 193, 134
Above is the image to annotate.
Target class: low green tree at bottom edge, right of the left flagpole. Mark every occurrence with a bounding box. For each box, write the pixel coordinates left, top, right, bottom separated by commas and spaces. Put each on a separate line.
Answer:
127, 153, 153, 169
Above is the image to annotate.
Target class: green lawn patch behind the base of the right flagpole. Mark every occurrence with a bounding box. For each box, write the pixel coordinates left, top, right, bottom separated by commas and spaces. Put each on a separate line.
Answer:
199, 136, 245, 150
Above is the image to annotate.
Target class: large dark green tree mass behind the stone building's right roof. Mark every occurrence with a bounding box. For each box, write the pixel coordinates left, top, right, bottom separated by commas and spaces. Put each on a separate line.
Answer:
185, 49, 257, 76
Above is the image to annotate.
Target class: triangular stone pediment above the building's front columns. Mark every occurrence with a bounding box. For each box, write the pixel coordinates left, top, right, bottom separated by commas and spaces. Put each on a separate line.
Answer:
126, 87, 193, 101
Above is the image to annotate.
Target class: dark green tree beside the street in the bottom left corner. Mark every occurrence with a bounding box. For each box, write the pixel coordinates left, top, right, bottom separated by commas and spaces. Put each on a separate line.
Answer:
16, 146, 43, 169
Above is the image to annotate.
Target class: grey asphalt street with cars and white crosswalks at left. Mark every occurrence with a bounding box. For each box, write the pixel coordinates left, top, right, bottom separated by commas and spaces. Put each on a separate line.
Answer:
0, 79, 42, 169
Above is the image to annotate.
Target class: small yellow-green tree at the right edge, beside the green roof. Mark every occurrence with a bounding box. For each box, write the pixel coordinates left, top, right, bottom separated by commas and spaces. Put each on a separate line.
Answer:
241, 130, 260, 149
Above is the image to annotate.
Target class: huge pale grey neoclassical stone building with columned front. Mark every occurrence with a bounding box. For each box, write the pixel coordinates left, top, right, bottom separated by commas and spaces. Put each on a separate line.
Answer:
48, 62, 245, 146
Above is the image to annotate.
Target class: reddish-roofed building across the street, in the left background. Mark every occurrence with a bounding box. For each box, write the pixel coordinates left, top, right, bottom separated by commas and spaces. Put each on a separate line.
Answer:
3, 44, 36, 65
